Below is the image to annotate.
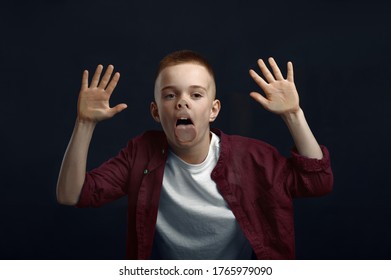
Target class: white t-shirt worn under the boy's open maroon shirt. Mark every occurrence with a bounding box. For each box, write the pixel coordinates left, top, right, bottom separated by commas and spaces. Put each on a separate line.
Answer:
152, 133, 252, 259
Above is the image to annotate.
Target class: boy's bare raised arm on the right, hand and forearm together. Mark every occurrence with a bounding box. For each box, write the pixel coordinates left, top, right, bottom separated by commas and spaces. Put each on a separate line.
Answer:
250, 58, 323, 159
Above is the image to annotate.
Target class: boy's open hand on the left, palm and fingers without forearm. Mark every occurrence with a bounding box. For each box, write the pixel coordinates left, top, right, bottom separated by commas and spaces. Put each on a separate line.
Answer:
77, 65, 127, 123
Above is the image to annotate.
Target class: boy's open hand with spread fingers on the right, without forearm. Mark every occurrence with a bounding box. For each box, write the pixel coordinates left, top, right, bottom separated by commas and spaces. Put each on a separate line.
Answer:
249, 58, 300, 115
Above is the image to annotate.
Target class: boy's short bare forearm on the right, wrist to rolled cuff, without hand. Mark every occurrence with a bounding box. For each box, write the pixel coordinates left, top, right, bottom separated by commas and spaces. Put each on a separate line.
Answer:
282, 109, 323, 159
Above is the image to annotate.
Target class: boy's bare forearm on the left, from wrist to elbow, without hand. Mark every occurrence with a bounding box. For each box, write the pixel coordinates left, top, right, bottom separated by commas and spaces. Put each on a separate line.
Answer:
57, 120, 96, 205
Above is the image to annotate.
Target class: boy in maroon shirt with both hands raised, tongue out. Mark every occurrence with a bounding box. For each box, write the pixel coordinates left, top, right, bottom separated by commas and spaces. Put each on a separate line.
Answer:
57, 51, 333, 259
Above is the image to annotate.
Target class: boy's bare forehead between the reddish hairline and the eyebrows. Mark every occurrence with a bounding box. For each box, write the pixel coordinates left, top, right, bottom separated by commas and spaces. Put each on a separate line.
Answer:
155, 63, 213, 90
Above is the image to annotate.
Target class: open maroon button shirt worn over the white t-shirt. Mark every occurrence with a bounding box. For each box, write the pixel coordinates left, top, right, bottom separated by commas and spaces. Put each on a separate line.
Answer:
77, 130, 333, 259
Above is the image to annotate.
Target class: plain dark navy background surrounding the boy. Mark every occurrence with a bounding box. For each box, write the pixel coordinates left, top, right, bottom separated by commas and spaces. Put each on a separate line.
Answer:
0, 0, 391, 259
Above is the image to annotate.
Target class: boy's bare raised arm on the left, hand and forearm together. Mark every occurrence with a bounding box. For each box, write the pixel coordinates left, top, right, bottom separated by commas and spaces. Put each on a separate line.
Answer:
57, 65, 127, 205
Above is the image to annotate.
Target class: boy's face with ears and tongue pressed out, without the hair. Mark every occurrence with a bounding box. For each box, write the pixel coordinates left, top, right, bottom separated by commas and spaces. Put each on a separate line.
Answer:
151, 63, 220, 151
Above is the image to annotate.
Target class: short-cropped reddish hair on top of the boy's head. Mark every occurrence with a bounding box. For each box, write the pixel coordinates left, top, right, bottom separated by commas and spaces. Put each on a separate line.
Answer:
156, 50, 215, 80
